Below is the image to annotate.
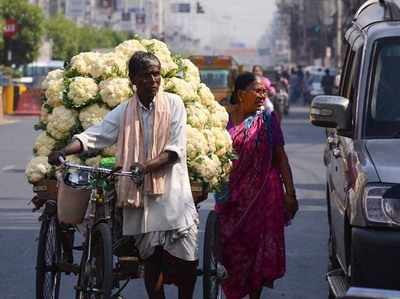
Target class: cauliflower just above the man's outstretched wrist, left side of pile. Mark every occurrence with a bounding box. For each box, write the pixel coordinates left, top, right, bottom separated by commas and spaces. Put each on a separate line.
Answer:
47, 106, 77, 140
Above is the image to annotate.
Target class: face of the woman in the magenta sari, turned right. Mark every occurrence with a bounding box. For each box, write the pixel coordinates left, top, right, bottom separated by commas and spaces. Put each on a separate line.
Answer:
239, 79, 267, 114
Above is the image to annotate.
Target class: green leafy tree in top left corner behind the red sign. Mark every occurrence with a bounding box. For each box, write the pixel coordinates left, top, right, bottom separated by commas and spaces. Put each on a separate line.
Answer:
0, 0, 44, 65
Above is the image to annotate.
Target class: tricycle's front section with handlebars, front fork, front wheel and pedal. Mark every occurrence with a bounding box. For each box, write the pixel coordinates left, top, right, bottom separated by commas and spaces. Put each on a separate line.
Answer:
57, 157, 142, 299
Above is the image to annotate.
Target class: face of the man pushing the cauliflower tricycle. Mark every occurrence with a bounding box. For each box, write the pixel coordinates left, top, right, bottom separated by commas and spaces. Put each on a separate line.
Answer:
131, 64, 161, 97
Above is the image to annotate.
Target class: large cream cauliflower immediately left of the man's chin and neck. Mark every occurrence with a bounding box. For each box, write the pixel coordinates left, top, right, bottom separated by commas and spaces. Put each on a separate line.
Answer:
99, 78, 133, 108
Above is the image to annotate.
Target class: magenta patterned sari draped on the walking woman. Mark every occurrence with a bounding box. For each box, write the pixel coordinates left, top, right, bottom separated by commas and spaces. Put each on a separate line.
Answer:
216, 112, 286, 299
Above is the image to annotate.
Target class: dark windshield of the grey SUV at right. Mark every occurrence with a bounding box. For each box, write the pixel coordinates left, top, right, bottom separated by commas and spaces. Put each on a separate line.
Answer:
366, 39, 400, 138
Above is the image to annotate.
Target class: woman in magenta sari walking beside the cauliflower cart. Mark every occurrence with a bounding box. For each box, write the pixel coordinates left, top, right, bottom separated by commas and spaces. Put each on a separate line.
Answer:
216, 73, 298, 299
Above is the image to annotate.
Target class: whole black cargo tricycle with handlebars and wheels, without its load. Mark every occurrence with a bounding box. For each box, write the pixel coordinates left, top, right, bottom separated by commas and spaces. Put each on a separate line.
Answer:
37, 156, 226, 299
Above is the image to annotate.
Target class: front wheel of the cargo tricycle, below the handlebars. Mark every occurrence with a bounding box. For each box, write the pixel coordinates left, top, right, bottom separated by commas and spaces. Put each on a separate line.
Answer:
76, 223, 113, 299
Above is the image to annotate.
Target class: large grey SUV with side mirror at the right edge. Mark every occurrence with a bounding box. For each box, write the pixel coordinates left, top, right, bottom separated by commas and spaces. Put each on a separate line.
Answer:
310, 0, 400, 298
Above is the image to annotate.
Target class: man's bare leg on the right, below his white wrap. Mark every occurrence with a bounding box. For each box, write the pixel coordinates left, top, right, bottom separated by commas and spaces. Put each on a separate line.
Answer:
163, 251, 198, 299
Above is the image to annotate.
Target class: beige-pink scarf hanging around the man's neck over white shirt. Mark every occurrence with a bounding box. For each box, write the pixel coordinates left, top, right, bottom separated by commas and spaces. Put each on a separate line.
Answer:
117, 92, 171, 208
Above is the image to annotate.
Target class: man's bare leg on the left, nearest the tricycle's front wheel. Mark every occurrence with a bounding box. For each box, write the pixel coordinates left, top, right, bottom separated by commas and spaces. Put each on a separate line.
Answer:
144, 247, 165, 299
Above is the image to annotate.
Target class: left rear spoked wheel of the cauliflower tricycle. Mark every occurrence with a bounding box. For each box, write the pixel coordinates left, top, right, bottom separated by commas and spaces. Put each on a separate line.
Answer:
36, 215, 61, 299
